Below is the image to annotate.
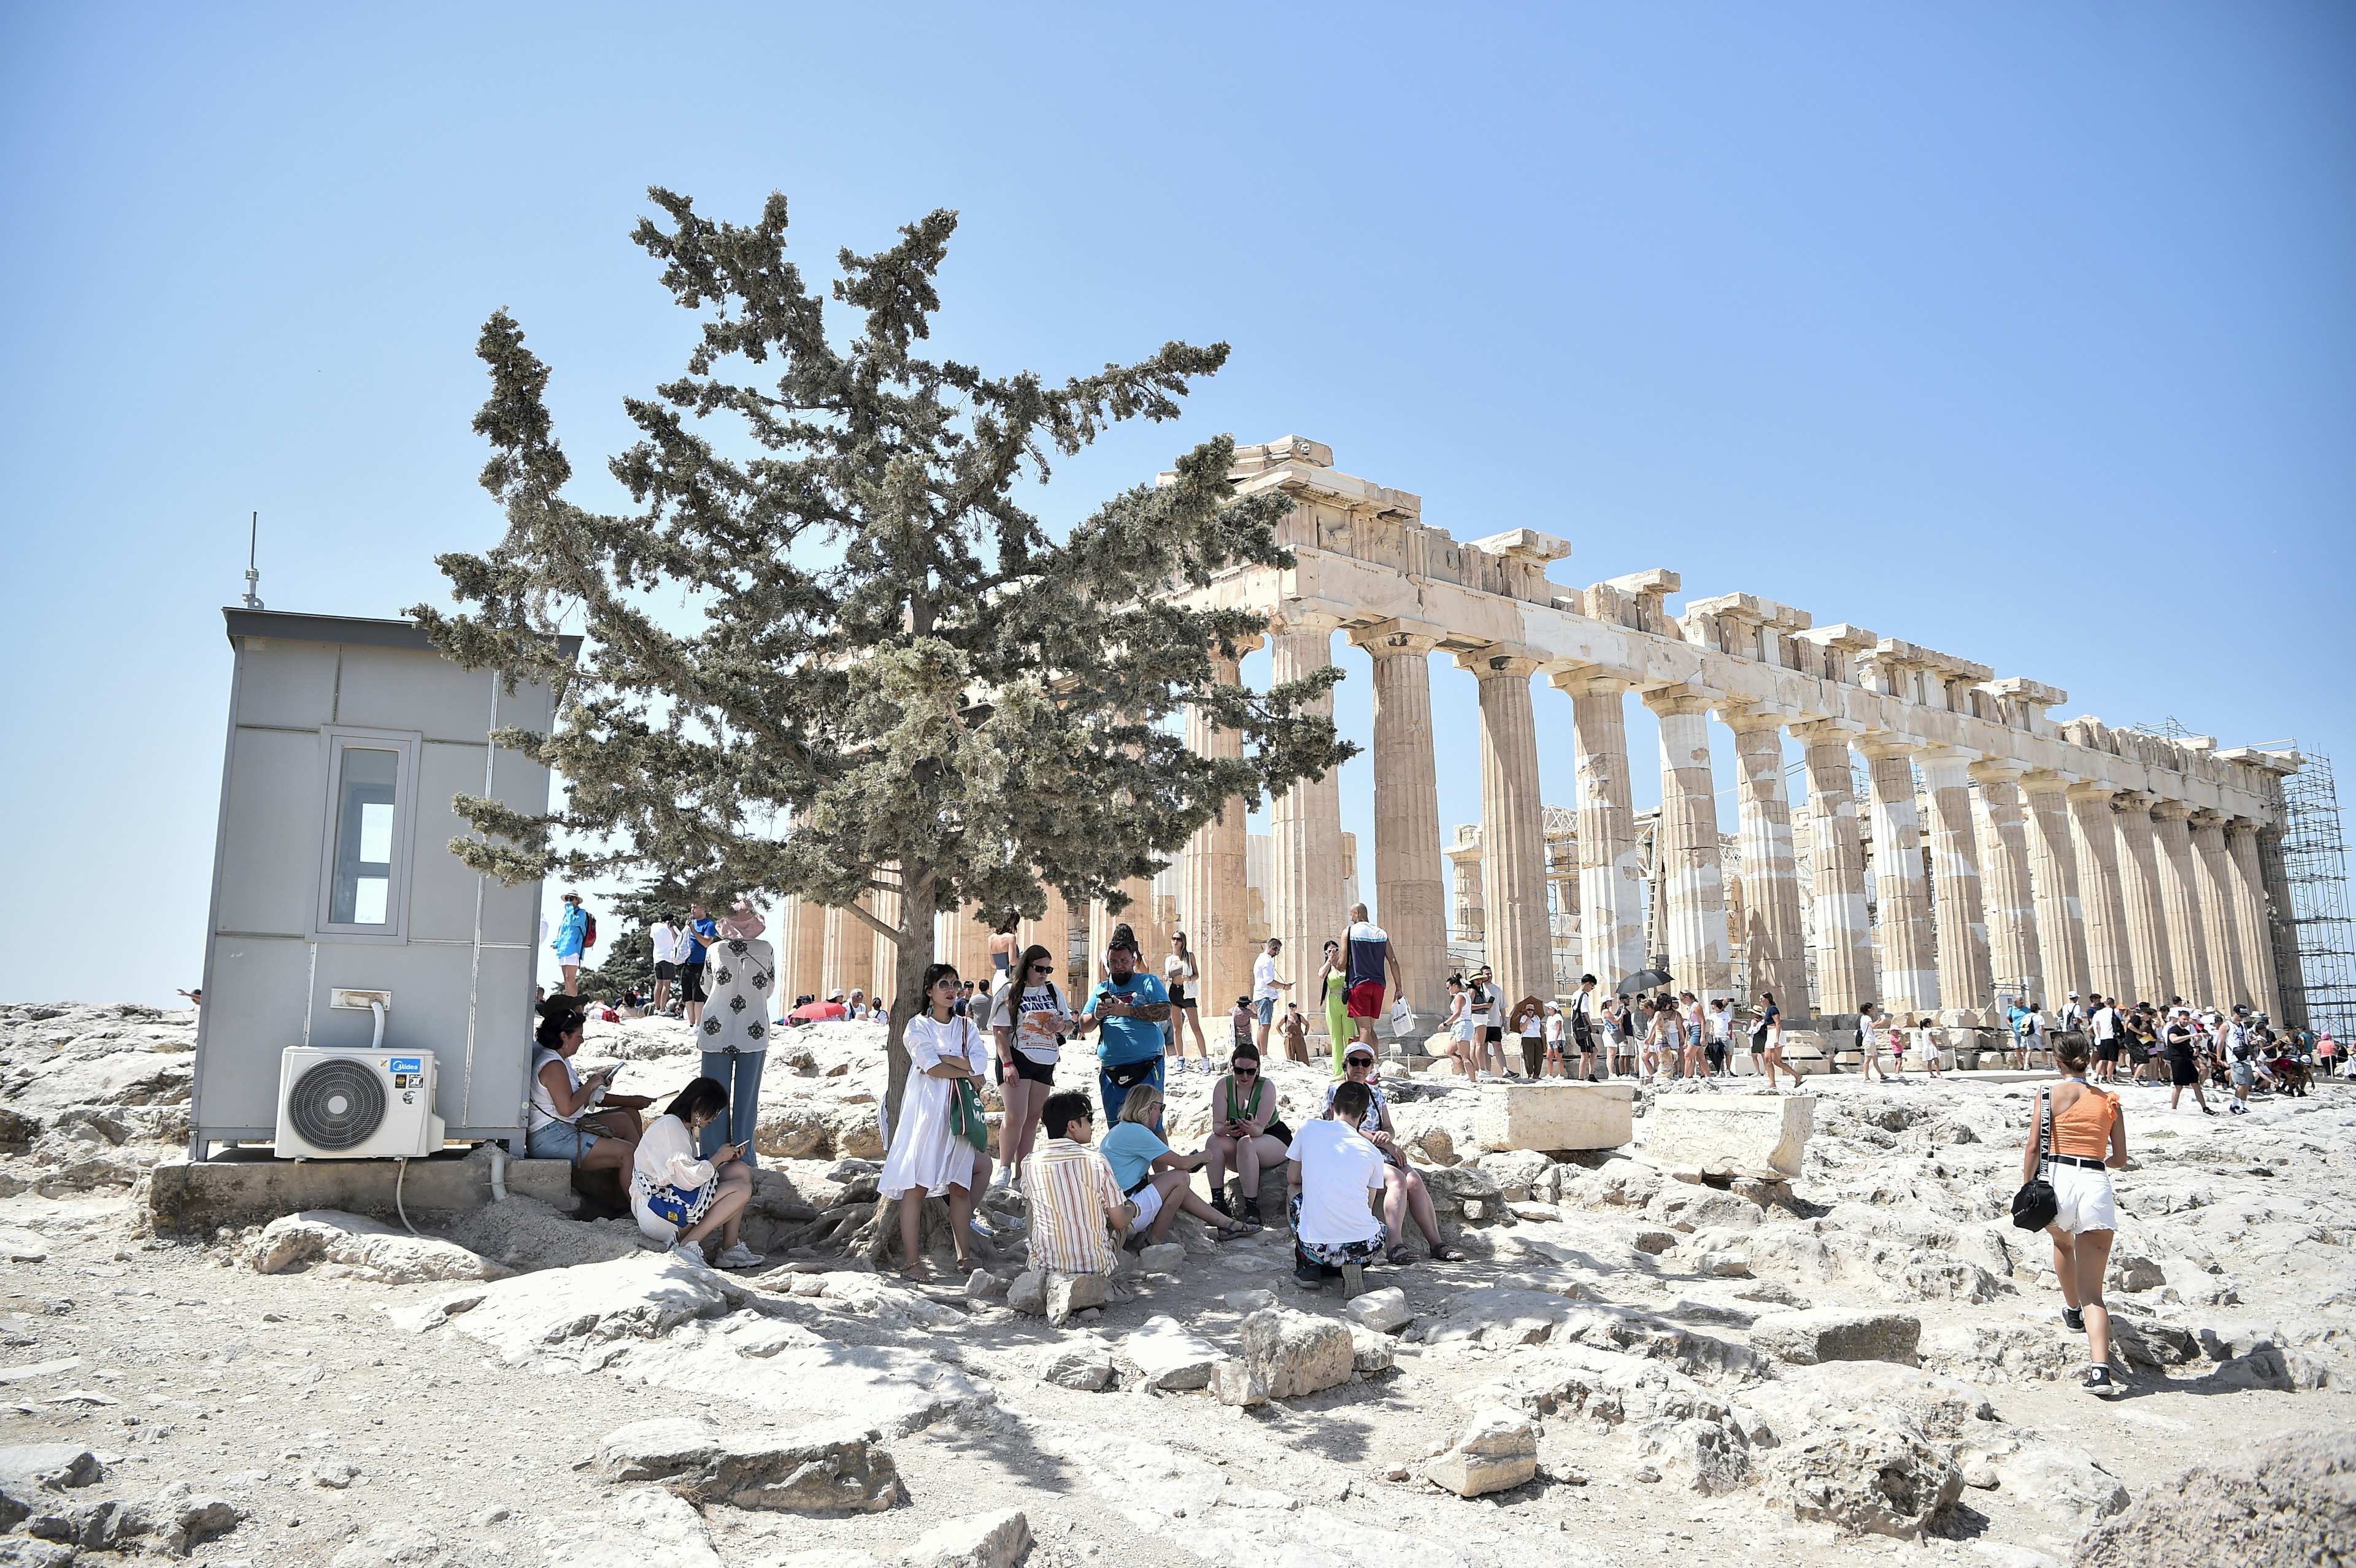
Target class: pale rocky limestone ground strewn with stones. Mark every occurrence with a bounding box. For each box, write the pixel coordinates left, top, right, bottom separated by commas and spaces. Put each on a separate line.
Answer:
0, 1005, 2356, 1568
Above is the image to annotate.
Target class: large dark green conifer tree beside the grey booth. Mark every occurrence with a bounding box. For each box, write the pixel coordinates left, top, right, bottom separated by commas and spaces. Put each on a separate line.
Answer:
412, 188, 1352, 1111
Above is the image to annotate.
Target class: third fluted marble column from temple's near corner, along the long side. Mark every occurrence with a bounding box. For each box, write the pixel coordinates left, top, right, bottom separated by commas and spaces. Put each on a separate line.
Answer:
1456, 647, 1555, 1001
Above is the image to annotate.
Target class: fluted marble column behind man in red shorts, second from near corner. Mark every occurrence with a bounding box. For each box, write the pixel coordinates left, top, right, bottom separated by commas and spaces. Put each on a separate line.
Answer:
1345, 621, 1449, 1015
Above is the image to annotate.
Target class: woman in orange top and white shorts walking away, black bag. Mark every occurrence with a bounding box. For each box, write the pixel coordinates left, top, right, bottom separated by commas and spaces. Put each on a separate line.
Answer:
2022, 1031, 2128, 1396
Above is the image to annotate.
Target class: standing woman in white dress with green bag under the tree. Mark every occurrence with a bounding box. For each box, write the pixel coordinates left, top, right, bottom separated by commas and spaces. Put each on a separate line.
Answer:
879, 963, 990, 1283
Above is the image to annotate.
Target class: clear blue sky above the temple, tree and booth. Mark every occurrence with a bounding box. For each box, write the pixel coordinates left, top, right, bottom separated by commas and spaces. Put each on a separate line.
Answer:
0, 2, 2356, 1001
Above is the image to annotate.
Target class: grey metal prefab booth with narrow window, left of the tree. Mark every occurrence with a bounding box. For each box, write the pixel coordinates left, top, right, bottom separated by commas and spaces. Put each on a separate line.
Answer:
188, 610, 565, 1158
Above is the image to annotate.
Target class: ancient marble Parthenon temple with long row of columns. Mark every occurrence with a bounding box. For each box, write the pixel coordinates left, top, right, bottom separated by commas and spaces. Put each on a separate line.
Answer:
782, 436, 2300, 1026
